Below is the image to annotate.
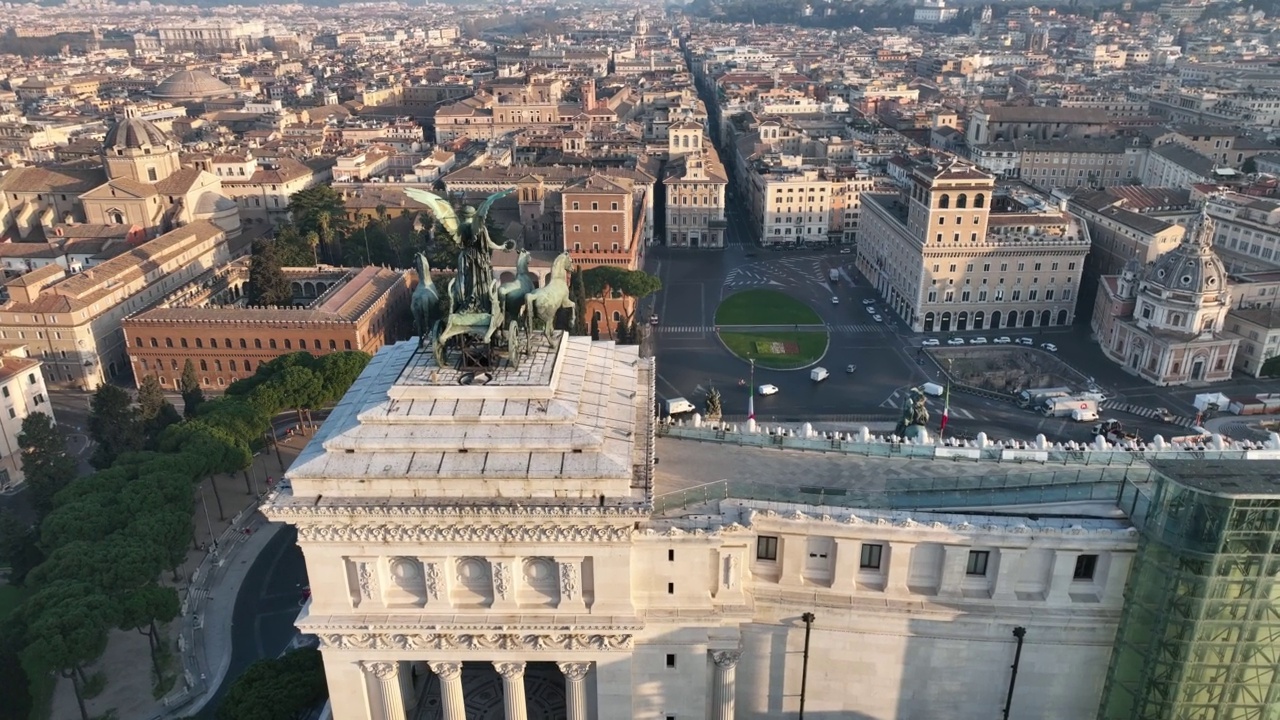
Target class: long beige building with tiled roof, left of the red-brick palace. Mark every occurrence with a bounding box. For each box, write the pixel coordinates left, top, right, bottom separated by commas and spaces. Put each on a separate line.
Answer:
0, 220, 240, 391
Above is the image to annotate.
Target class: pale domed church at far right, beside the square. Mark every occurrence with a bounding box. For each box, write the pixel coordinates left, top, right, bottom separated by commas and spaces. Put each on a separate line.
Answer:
1092, 210, 1239, 386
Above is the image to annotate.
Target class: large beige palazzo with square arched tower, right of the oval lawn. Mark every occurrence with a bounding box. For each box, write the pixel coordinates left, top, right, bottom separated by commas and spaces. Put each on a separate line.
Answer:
856, 160, 1089, 332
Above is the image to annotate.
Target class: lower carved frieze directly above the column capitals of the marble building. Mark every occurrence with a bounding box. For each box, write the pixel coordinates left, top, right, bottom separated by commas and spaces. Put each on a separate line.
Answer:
317, 632, 635, 651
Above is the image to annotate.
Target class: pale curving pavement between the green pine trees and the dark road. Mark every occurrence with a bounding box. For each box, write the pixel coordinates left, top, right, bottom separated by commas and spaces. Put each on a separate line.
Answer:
50, 436, 308, 720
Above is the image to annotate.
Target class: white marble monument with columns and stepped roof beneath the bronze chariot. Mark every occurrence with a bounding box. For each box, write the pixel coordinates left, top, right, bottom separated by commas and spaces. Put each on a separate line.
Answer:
264, 336, 1137, 720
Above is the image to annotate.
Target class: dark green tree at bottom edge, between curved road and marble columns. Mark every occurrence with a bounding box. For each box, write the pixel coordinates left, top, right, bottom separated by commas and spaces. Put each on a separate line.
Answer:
216, 648, 329, 720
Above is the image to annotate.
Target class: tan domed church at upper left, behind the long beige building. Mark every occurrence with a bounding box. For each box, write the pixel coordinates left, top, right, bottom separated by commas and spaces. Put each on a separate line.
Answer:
79, 105, 239, 237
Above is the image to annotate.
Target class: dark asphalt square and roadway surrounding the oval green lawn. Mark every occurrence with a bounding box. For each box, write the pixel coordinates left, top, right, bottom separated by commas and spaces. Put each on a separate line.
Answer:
646, 226, 1223, 441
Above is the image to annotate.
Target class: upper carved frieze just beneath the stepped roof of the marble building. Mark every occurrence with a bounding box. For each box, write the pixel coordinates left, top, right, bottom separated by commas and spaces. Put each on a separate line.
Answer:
298, 524, 632, 543
